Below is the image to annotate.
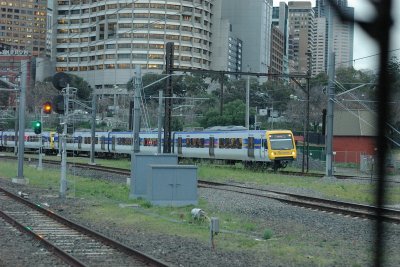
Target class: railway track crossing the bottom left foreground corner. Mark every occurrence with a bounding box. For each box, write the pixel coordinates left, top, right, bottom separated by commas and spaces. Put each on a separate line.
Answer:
0, 188, 167, 266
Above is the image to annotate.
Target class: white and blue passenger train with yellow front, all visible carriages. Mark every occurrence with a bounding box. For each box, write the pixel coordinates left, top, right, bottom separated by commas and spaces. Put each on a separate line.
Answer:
0, 130, 297, 169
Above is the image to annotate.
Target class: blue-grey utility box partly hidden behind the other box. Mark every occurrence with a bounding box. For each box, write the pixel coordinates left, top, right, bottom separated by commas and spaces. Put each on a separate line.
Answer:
129, 153, 178, 198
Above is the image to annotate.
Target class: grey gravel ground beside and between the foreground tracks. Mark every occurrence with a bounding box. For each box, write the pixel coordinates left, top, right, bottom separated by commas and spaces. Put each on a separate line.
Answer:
0, 166, 400, 267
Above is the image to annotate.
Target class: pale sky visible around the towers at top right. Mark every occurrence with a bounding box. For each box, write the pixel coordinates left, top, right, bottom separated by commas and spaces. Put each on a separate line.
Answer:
274, 0, 400, 71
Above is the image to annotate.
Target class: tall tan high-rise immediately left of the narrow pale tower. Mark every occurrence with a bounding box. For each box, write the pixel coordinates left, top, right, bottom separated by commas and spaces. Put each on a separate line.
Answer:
288, 1, 315, 75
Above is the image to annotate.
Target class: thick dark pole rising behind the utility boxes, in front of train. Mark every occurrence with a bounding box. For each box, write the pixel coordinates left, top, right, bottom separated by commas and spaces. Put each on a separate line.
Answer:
164, 42, 174, 153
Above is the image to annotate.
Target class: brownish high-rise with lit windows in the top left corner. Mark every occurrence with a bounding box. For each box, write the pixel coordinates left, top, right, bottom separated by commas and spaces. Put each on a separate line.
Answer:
0, 0, 47, 56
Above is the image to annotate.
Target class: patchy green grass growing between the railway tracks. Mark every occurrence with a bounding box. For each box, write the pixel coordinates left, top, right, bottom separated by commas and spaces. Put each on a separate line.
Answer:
0, 158, 399, 266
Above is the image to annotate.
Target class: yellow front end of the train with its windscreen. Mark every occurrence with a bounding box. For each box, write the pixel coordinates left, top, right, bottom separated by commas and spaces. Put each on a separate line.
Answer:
266, 130, 297, 169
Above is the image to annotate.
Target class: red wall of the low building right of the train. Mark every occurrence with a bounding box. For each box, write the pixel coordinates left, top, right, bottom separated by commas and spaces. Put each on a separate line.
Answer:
333, 136, 376, 163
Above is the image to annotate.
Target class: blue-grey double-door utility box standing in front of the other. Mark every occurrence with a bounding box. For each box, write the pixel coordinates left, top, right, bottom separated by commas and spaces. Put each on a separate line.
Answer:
147, 165, 198, 206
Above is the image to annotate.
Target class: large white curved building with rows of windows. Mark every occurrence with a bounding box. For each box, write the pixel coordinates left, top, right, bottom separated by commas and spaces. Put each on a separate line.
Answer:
52, 0, 214, 89
